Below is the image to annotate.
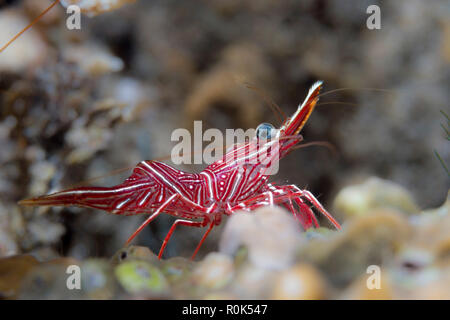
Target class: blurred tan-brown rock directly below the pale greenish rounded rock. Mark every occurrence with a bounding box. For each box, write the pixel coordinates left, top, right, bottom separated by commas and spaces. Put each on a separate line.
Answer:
298, 210, 411, 287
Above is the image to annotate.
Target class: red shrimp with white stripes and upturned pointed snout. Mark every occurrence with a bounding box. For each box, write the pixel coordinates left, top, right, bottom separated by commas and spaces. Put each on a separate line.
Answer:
20, 81, 341, 259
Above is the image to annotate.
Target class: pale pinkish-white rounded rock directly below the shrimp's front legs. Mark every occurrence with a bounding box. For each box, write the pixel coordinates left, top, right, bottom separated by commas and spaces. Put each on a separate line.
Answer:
219, 207, 301, 269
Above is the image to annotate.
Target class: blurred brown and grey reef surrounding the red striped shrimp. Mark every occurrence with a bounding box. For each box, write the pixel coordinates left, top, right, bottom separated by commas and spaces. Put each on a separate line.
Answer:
0, 0, 450, 299
